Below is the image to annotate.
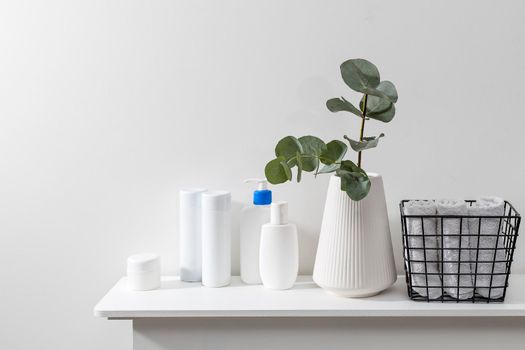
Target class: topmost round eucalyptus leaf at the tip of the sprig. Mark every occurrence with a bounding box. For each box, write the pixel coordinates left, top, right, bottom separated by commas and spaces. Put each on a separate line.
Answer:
341, 58, 380, 93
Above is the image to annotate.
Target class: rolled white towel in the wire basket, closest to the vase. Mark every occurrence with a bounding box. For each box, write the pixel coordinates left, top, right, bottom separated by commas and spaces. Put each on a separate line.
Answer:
404, 201, 442, 299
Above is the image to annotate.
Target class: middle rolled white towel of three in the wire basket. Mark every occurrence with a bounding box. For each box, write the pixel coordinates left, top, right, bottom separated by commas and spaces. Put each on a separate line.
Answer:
436, 199, 474, 299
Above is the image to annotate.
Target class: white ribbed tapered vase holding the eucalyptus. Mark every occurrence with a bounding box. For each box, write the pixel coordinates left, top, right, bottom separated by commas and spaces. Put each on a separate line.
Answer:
313, 173, 396, 298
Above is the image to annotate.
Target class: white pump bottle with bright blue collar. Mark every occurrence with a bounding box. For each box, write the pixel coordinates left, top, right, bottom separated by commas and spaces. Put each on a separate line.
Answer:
240, 179, 272, 284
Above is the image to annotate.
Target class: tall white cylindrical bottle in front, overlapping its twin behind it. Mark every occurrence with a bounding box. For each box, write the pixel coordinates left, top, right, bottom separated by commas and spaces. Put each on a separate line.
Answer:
202, 191, 231, 287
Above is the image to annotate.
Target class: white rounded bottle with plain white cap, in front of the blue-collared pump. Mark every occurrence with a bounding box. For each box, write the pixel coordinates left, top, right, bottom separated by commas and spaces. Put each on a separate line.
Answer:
259, 202, 299, 289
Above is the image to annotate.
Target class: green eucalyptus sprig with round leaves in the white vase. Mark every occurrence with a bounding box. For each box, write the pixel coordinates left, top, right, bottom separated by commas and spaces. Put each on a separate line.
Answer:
264, 58, 398, 201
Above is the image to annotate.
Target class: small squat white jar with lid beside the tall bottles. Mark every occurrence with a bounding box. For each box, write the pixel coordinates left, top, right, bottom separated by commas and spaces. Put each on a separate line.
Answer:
127, 253, 160, 290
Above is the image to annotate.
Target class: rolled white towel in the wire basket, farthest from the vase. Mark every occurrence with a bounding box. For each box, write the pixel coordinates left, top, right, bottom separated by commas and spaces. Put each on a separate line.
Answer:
469, 197, 506, 298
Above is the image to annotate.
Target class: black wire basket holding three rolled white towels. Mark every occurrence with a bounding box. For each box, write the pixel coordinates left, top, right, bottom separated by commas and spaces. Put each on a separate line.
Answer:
399, 200, 521, 303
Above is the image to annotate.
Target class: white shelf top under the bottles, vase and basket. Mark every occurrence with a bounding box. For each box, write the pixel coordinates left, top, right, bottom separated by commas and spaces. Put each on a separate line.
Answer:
94, 274, 525, 319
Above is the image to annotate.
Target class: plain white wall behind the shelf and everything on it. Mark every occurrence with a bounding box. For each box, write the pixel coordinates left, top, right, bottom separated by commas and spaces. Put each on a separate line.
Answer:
0, 0, 525, 350
